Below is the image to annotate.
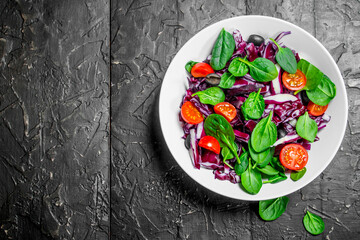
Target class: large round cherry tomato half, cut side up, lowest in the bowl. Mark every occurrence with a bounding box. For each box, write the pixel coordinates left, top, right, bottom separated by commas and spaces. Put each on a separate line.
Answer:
280, 143, 309, 170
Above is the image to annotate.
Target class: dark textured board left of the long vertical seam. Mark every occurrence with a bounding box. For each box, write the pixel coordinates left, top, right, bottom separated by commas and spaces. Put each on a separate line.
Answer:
0, 0, 110, 239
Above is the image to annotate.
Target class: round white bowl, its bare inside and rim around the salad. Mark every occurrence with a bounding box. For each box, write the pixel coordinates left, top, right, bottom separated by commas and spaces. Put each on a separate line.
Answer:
159, 16, 348, 201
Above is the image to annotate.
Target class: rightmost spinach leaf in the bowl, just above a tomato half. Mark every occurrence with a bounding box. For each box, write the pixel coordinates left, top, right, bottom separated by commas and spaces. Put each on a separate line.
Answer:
306, 75, 336, 106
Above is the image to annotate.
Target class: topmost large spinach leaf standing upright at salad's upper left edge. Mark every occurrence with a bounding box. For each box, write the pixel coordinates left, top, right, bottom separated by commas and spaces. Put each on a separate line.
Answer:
210, 28, 235, 70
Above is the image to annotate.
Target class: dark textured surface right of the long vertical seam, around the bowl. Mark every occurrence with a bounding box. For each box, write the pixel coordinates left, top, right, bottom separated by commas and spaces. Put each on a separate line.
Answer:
111, 0, 360, 239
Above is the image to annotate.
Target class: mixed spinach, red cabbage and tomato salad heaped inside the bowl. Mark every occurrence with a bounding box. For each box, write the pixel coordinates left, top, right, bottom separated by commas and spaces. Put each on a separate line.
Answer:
179, 29, 336, 194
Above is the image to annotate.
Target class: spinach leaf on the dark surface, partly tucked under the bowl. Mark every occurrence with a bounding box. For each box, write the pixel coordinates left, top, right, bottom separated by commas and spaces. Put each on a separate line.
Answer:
259, 196, 289, 221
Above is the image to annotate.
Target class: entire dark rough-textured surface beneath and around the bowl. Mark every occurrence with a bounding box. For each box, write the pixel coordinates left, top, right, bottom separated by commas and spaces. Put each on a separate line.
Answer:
0, 0, 360, 239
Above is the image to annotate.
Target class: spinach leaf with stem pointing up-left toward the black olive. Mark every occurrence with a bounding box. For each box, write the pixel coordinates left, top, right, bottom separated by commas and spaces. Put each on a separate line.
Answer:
270, 38, 297, 74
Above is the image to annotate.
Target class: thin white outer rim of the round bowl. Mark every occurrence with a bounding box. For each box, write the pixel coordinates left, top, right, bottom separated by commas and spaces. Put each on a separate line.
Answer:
159, 15, 348, 201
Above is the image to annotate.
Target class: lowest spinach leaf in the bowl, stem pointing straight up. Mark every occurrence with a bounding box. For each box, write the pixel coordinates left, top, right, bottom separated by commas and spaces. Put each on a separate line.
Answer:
240, 158, 262, 194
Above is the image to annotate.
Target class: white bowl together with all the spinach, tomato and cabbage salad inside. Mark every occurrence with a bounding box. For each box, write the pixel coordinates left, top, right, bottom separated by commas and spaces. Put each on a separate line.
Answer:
159, 16, 348, 201
